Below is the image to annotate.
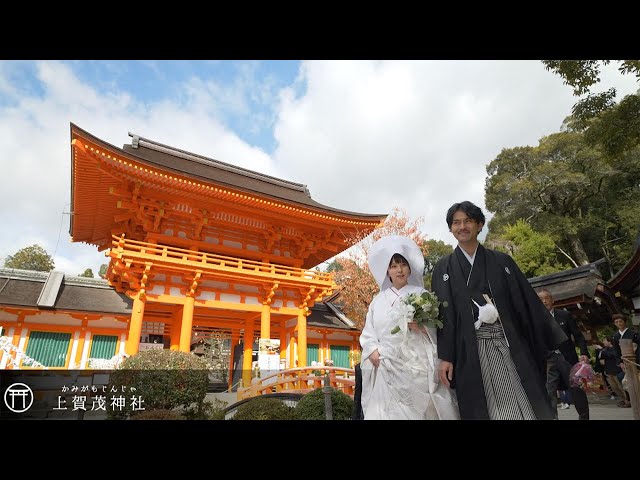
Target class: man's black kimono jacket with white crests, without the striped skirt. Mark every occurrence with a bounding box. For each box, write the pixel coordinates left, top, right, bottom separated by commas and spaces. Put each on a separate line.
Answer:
431, 245, 566, 420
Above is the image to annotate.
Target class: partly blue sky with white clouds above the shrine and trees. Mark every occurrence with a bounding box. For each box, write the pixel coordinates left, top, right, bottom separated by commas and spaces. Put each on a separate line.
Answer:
0, 60, 638, 275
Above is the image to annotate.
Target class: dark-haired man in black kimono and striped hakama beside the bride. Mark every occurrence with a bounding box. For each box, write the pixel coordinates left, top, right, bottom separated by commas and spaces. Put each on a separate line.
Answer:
431, 201, 566, 420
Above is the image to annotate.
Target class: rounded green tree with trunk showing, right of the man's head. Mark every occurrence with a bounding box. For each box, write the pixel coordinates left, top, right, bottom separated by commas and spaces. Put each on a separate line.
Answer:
485, 132, 613, 265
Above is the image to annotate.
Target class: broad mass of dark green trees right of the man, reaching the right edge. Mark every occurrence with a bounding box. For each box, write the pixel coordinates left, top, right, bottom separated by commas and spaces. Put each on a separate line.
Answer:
485, 131, 640, 275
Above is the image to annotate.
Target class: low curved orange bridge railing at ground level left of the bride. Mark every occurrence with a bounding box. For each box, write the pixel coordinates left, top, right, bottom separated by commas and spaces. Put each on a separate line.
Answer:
238, 367, 355, 400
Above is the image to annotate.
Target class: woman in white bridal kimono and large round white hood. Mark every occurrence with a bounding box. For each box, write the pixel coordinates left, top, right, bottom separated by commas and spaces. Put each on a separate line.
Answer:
360, 235, 460, 420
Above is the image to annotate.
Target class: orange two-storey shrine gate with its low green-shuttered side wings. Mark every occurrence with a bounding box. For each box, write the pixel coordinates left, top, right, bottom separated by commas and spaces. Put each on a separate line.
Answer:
0, 124, 386, 385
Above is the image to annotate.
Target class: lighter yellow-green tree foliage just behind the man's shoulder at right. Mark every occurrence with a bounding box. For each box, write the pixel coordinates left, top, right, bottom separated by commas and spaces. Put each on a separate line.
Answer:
494, 219, 570, 278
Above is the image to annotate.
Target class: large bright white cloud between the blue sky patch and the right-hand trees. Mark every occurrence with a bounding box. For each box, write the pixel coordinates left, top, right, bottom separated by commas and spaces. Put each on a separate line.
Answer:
274, 61, 637, 251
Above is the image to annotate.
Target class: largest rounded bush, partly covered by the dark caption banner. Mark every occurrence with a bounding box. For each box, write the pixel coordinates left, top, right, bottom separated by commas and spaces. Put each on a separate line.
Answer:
108, 350, 209, 417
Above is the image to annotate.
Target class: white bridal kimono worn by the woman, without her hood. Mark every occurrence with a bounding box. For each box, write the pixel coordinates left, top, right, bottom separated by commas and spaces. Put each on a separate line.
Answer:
360, 285, 460, 420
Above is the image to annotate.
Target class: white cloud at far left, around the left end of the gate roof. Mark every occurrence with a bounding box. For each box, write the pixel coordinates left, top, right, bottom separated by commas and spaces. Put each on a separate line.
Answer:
0, 62, 272, 275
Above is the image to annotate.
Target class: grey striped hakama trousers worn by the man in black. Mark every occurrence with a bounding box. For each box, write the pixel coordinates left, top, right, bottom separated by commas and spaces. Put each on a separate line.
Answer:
476, 321, 536, 420
